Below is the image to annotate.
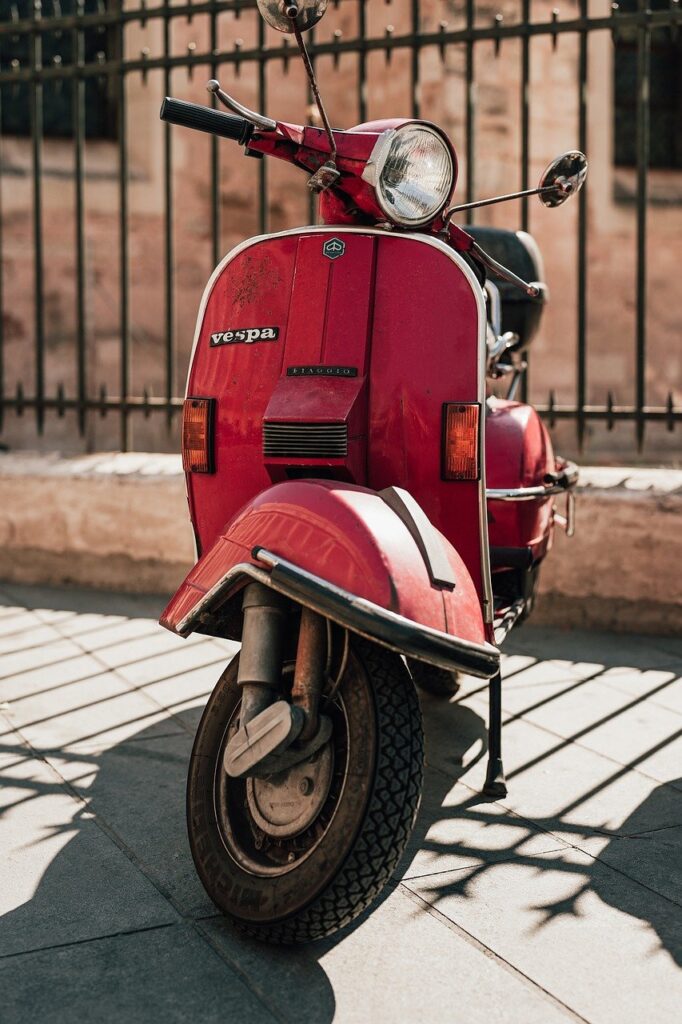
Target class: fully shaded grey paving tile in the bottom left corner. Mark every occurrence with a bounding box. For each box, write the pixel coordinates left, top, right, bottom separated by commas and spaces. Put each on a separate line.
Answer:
0, 925, 276, 1024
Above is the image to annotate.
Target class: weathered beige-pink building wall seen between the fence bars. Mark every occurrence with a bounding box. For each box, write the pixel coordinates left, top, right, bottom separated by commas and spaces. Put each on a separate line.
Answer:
1, 0, 682, 462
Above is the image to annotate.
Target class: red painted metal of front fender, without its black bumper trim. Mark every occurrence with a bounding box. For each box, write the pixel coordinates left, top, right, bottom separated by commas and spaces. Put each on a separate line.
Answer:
161, 480, 485, 643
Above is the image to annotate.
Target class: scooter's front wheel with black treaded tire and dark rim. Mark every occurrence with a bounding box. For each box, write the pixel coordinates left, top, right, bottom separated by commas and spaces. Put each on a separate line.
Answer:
187, 638, 424, 943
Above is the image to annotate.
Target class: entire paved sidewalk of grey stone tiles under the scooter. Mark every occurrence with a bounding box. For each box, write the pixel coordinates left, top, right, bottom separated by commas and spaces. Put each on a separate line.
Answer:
0, 585, 682, 1024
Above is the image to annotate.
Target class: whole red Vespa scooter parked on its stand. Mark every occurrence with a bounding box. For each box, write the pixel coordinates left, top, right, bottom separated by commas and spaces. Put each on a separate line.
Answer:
156, 0, 587, 942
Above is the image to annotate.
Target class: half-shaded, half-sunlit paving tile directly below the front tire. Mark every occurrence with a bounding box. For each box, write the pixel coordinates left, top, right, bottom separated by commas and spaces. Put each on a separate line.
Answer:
202, 889, 573, 1024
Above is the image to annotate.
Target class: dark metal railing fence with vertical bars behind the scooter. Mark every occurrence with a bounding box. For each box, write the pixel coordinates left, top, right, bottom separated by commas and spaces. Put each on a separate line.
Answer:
0, 0, 682, 450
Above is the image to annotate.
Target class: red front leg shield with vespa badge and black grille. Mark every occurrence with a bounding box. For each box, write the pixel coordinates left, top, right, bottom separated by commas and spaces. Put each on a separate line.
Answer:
187, 227, 491, 609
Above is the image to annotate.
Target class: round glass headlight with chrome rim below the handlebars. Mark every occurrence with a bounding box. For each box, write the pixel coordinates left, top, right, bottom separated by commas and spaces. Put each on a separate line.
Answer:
363, 122, 455, 227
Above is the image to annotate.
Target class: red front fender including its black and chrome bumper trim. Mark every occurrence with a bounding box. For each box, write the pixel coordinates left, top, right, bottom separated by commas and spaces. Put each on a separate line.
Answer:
161, 480, 499, 677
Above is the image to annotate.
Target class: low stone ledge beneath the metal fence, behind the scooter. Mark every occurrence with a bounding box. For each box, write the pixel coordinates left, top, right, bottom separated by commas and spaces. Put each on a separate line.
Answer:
0, 453, 682, 635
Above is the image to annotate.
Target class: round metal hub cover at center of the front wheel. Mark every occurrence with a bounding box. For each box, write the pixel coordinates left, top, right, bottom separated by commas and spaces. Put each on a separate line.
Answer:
247, 743, 334, 839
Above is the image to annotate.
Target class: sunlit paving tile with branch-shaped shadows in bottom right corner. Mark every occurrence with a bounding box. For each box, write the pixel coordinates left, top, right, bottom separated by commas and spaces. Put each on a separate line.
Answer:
403, 850, 682, 1024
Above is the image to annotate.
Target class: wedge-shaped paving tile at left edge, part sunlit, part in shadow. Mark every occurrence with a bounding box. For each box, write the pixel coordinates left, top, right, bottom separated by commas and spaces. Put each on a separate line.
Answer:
0, 741, 177, 954
